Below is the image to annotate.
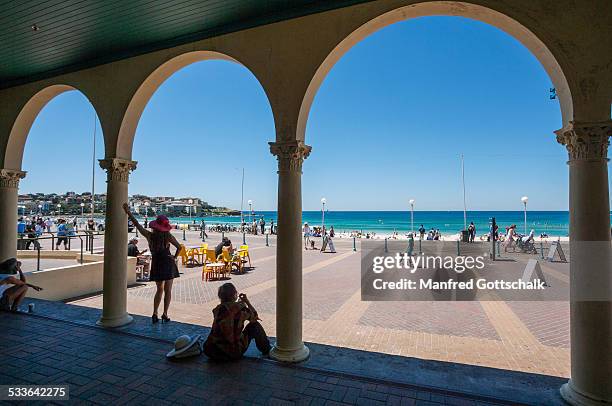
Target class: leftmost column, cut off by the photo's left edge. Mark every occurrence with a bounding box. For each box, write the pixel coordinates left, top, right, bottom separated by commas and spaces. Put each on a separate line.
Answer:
0, 169, 26, 262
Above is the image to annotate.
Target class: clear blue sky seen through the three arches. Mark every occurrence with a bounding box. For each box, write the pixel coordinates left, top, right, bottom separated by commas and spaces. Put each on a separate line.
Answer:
21, 17, 608, 210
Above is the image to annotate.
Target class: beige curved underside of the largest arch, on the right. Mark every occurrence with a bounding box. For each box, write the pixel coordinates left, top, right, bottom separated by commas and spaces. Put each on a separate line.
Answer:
296, 1, 574, 141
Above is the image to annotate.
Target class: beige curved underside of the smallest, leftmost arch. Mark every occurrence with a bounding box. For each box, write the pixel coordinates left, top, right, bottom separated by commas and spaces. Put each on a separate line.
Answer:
4, 84, 91, 170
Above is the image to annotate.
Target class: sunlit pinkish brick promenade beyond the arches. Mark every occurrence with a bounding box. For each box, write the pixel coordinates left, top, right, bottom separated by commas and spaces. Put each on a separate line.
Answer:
72, 232, 570, 377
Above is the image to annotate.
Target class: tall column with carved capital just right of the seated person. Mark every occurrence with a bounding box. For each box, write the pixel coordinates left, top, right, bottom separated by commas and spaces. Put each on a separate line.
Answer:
270, 141, 311, 362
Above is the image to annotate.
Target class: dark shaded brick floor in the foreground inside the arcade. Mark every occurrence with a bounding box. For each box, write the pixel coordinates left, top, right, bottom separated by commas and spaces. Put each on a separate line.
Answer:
0, 313, 510, 406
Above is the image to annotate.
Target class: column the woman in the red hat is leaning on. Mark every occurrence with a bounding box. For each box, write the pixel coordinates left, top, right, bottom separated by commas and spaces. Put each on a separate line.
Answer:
98, 158, 136, 327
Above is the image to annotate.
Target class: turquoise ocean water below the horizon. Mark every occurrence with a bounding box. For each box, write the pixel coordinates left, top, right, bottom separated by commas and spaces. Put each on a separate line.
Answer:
164, 211, 608, 237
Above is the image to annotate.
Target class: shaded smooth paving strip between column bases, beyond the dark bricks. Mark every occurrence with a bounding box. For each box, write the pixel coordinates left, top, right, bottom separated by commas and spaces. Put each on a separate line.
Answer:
20, 298, 566, 405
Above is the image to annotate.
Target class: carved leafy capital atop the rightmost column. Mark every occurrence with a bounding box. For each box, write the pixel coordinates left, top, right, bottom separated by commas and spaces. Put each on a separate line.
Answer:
555, 120, 612, 162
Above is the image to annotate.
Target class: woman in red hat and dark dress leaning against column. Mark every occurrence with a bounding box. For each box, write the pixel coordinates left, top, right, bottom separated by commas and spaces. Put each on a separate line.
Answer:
123, 203, 181, 323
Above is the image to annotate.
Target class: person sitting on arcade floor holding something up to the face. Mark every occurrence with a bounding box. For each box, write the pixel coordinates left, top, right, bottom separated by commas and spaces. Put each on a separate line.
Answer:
204, 283, 270, 361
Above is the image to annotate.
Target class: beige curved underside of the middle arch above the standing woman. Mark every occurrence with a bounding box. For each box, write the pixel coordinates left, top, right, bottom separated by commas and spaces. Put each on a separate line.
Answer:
115, 51, 269, 159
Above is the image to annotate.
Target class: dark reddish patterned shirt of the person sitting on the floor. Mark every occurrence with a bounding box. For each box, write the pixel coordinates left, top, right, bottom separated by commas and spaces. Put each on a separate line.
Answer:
206, 302, 257, 359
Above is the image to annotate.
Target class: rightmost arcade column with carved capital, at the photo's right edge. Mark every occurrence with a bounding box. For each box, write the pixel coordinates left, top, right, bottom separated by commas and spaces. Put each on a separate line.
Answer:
556, 121, 612, 405
